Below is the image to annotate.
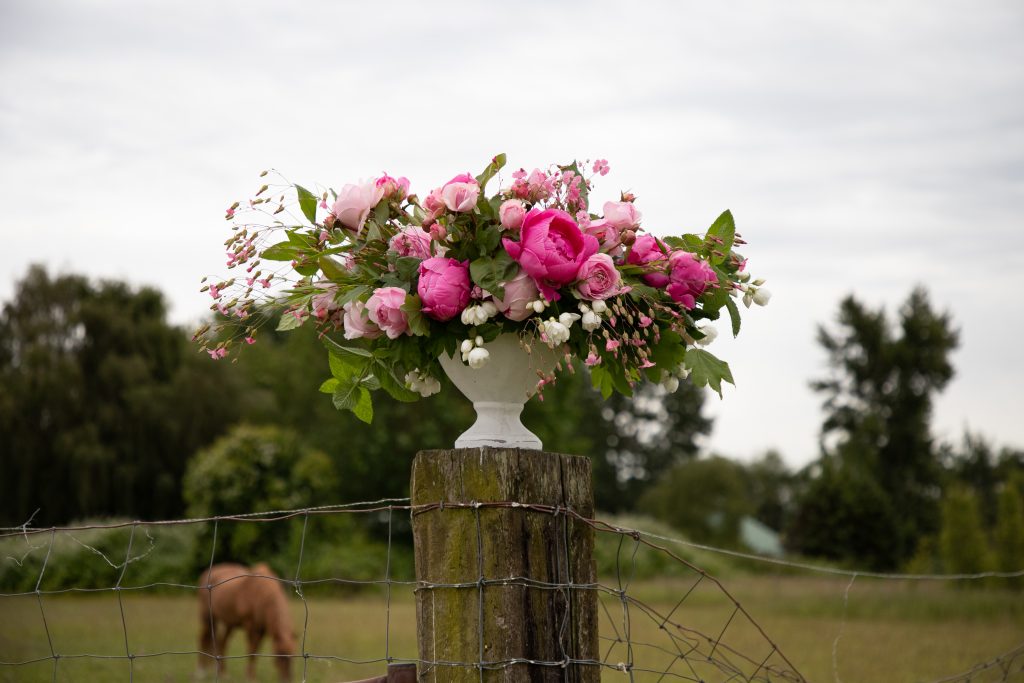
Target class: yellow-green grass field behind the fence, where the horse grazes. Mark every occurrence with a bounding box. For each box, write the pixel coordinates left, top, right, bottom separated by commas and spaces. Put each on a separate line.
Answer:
0, 575, 1024, 683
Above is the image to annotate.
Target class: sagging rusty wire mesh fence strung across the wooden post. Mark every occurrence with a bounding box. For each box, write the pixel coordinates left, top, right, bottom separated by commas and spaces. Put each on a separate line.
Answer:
0, 499, 1024, 683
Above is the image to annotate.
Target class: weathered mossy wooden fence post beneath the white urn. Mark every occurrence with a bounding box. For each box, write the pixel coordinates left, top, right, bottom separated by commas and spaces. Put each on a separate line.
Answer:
411, 447, 601, 683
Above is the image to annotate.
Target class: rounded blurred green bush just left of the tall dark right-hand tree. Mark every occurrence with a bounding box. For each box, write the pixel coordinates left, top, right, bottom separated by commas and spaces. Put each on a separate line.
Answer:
640, 457, 754, 547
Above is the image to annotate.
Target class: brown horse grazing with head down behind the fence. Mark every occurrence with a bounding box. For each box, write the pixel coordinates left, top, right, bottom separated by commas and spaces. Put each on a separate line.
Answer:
199, 563, 295, 681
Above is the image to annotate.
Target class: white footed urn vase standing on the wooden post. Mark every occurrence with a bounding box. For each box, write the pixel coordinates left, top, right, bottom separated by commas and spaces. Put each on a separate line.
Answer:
438, 334, 558, 451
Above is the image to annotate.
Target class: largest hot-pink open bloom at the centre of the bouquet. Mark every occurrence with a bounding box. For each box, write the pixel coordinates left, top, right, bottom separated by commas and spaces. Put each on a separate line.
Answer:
502, 209, 598, 301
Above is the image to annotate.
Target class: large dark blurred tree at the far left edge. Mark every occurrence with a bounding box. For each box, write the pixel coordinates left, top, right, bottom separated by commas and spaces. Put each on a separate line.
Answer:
0, 266, 243, 524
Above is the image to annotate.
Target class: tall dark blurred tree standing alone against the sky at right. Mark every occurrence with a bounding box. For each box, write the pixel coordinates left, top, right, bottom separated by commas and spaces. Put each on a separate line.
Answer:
801, 289, 957, 566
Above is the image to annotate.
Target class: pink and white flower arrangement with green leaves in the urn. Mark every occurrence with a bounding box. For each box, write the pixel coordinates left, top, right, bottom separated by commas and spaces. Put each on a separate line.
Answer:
197, 155, 770, 422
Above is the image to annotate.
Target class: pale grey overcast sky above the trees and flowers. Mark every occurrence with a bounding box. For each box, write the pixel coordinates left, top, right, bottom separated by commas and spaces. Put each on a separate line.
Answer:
0, 0, 1024, 465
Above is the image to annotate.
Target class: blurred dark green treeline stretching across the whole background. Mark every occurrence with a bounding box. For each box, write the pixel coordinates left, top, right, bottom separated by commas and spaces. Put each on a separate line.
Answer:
0, 267, 1024, 583
